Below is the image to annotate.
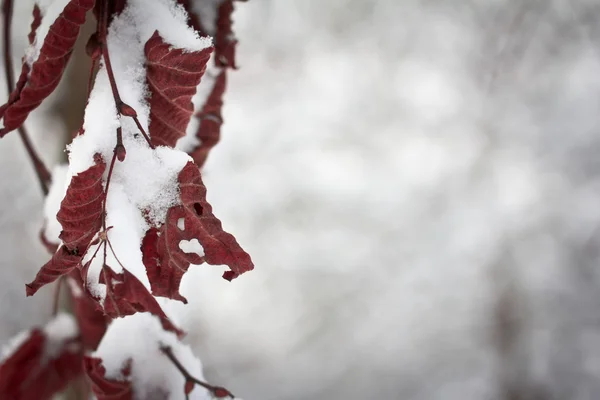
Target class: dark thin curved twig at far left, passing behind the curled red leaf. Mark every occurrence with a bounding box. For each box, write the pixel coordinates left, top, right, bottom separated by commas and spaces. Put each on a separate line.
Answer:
2, 0, 51, 195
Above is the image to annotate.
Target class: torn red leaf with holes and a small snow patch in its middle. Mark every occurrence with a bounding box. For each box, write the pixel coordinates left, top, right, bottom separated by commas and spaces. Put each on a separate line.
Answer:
142, 162, 254, 303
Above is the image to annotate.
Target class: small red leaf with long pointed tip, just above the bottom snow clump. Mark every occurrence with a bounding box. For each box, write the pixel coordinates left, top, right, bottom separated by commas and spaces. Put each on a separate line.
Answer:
94, 266, 183, 336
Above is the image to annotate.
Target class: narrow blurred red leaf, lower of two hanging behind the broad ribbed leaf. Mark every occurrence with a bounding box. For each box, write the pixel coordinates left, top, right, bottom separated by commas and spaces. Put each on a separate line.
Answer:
189, 69, 227, 168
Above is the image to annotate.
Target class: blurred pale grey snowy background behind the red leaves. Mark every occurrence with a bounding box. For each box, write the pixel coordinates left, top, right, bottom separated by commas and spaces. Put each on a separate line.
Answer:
0, 0, 600, 400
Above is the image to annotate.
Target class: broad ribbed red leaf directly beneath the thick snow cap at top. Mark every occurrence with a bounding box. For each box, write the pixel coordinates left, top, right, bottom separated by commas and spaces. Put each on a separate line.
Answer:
144, 31, 212, 147
